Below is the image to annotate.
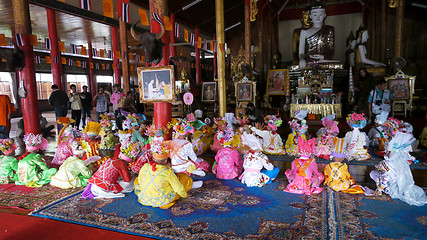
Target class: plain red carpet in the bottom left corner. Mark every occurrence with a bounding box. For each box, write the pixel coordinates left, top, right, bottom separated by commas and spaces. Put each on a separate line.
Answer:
0, 212, 154, 240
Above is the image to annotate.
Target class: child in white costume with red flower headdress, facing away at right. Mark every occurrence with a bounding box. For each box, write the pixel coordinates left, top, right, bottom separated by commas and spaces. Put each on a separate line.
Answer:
345, 113, 371, 161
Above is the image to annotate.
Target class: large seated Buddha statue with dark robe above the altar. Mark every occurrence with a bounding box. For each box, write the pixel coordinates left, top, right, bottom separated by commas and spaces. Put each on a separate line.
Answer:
299, 1, 335, 69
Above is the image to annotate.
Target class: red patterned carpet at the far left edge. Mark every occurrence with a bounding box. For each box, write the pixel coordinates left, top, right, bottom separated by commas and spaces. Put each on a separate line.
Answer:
0, 184, 82, 210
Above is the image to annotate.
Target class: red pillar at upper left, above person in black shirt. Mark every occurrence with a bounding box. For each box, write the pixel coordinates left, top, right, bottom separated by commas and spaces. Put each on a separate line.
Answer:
46, 8, 65, 90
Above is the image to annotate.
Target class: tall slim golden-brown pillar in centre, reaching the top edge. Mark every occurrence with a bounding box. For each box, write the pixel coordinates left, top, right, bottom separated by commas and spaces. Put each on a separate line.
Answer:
215, 0, 227, 117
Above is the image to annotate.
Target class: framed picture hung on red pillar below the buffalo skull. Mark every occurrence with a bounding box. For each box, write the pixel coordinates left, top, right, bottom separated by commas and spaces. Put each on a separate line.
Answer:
138, 65, 175, 102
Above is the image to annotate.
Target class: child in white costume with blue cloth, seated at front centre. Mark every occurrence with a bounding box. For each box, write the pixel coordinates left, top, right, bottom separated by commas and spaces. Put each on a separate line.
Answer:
239, 129, 280, 187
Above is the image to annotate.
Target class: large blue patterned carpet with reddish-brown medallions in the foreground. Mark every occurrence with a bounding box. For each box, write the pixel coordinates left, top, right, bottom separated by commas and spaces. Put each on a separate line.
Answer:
32, 175, 427, 239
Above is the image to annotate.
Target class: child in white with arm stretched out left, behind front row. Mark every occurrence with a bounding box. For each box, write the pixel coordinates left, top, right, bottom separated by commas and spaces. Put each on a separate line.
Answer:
251, 115, 286, 155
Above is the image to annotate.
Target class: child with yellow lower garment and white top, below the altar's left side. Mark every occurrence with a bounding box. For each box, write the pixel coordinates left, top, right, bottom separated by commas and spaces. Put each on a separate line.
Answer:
285, 110, 308, 156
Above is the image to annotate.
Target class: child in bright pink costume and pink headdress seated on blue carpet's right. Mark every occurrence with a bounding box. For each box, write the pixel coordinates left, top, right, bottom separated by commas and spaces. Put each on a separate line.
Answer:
284, 137, 324, 195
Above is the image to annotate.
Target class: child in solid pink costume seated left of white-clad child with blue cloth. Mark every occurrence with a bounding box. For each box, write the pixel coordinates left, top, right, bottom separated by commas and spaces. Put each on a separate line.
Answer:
212, 129, 243, 179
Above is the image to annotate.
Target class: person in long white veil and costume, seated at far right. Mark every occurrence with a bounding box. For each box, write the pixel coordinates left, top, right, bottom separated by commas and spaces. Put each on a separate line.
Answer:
370, 131, 427, 206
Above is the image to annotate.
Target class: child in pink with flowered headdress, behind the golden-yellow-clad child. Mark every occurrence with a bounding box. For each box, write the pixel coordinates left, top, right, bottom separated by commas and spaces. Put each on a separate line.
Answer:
314, 117, 339, 160
